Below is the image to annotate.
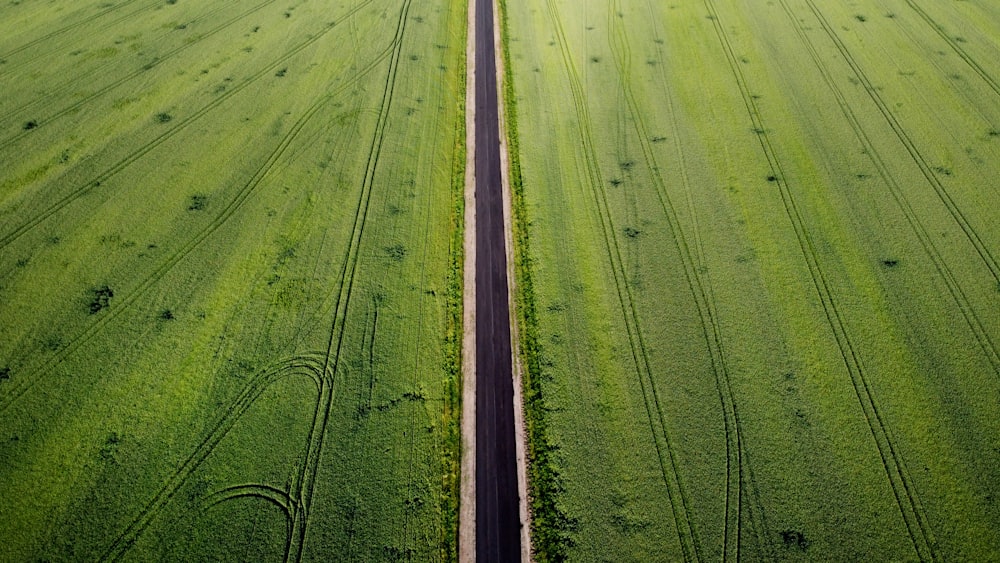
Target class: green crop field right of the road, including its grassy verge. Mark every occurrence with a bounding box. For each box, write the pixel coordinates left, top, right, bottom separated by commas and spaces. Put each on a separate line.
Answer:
504, 0, 1000, 561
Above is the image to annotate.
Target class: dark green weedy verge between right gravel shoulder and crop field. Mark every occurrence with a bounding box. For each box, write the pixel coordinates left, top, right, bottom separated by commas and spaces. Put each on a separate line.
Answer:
499, 0, 576, 561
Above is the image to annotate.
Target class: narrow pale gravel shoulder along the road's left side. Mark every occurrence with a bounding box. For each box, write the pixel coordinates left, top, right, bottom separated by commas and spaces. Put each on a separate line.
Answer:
458, 0, 476, 561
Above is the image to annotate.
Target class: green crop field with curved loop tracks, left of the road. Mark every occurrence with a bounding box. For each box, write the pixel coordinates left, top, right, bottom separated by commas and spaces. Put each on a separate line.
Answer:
0, 0, 466, 561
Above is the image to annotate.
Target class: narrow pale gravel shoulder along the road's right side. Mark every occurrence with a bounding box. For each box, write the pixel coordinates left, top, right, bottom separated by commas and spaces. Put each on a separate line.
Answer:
493, 0, 532, 563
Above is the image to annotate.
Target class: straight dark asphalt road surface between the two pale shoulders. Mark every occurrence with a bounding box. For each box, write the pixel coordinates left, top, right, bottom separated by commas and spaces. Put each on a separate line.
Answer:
475, 0, 521, 563
